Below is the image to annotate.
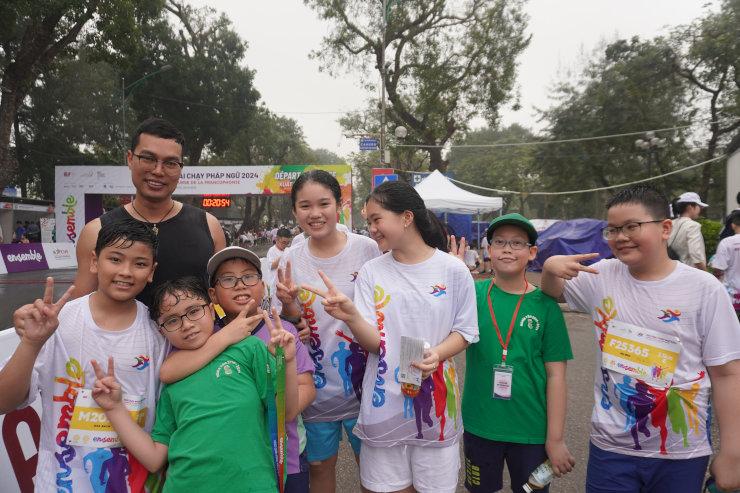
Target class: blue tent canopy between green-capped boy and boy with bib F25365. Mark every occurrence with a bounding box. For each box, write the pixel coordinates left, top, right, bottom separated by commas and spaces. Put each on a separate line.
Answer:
530, 219, 612, 272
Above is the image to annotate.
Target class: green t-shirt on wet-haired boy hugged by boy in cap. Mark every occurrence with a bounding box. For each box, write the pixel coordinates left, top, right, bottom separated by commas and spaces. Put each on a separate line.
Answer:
152, 337, 277, 492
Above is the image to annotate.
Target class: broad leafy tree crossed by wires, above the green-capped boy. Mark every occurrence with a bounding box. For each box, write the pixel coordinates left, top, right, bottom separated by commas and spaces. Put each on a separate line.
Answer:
537, 37, 695, 217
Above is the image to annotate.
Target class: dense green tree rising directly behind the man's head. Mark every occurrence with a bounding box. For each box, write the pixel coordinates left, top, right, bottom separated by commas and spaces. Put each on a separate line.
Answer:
127, 0, 259, 165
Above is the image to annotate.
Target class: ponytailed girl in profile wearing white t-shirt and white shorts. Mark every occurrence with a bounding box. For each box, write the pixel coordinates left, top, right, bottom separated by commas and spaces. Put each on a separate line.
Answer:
304, 182, 478, 493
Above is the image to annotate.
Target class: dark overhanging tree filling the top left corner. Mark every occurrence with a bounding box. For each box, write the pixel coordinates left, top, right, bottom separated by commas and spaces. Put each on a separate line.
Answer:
0, 0, 161, 188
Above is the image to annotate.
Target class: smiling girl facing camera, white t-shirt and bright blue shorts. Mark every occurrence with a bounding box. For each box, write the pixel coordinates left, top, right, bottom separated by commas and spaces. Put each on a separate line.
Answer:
275, 170, 380, 491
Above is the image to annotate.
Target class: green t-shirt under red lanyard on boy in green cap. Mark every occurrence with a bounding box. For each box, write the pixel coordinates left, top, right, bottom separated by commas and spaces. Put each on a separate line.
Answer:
462, 279, 573, 444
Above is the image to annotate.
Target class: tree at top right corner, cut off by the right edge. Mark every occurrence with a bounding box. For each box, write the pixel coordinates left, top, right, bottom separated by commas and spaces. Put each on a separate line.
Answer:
670, 0, 740, 202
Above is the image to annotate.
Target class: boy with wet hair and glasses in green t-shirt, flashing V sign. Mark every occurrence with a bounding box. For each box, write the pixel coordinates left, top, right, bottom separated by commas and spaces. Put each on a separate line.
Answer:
92, 278, 298, 493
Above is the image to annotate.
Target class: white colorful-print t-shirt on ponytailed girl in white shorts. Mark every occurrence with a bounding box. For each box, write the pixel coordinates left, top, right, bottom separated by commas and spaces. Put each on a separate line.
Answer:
355, 250, 478, 447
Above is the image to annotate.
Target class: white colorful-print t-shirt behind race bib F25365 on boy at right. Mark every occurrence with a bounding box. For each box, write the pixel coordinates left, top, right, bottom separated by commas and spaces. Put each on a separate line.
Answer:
565, 259, 740, 459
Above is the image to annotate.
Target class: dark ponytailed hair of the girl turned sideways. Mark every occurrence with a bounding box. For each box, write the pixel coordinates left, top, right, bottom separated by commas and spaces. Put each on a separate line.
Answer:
365, 181, 449, 252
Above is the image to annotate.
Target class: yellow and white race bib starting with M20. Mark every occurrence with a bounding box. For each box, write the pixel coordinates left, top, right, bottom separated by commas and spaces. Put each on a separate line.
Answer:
67, 389, 147, 448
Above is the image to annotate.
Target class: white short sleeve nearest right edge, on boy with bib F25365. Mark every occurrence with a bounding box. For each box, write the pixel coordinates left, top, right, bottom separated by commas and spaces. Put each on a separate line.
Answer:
700, 279, 740, 366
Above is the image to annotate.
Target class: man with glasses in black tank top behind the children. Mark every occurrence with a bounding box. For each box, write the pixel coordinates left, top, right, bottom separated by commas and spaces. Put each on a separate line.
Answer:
74, 118, 226, 305
